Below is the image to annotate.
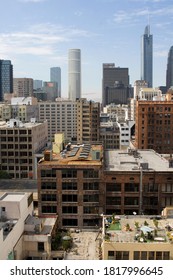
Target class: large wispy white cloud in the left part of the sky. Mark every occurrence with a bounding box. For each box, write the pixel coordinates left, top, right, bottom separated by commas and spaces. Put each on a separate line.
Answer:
0, 23, 92, 56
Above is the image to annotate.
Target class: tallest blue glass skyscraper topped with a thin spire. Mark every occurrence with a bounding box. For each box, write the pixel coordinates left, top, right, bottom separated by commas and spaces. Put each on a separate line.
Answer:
141, 25, 153, 87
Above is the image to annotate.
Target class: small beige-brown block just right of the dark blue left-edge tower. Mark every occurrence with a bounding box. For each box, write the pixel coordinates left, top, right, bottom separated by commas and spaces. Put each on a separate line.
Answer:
13, 78, 33, 97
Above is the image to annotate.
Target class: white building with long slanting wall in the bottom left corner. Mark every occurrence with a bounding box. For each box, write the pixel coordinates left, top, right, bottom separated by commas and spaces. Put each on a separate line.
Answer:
0, 193, 33, 260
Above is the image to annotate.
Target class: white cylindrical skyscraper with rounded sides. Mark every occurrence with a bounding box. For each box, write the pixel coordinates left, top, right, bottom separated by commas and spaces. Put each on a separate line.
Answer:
68, 49, 81, 100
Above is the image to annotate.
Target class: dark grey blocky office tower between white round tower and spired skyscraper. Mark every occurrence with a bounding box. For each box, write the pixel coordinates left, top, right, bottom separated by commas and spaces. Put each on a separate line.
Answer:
102, 63, 131, 107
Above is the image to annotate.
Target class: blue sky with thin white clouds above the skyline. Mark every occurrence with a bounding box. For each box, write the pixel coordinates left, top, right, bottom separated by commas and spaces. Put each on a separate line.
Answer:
0, 0, 173, 101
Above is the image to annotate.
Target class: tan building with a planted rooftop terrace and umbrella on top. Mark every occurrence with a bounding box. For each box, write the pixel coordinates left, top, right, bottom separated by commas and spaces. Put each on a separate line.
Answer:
101, 213, 173, 260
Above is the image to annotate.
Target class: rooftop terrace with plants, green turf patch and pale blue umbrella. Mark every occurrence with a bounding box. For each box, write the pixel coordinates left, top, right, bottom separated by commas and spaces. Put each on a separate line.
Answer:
103, 216, 173, 243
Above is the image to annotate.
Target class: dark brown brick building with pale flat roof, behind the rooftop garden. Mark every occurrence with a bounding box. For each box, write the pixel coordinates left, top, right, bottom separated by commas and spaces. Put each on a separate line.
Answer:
104, 149, 173, 215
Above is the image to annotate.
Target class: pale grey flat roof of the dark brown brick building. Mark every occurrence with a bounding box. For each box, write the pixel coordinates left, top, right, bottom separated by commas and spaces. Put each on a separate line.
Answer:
105, 150, 173, 171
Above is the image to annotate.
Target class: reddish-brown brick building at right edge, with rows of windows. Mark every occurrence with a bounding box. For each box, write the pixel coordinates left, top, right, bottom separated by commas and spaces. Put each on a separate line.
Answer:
134, 92, 173, 154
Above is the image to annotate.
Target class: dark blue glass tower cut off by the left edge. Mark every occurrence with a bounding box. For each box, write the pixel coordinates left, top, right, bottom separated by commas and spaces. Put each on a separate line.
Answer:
0, 60, 13, 101
